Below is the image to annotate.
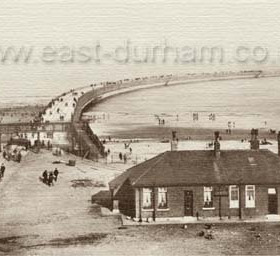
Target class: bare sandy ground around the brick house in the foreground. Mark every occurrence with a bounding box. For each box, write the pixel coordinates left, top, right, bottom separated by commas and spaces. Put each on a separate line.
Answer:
0, 149, 280, 256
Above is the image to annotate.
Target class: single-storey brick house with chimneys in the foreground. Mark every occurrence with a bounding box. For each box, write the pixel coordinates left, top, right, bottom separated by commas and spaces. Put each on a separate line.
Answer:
109, 129, 280, 221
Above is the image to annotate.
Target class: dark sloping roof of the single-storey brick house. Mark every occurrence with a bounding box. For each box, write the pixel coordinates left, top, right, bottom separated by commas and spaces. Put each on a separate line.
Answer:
109, 150, 280, 189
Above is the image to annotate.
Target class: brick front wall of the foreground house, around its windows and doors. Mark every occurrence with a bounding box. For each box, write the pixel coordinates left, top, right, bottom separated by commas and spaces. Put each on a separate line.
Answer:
134, 185, 280, 219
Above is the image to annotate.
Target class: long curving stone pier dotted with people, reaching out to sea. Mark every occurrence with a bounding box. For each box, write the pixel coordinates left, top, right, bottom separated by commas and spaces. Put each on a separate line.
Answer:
42, 71, 270, 160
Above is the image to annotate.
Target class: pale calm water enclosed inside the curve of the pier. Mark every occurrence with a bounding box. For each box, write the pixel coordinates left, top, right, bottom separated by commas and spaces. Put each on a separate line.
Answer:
87, 77, 280, 135
